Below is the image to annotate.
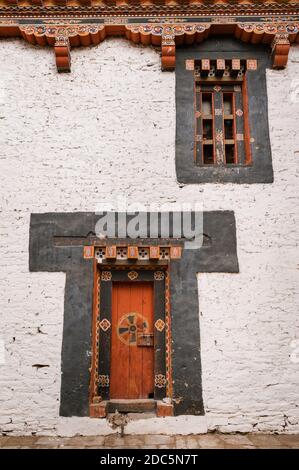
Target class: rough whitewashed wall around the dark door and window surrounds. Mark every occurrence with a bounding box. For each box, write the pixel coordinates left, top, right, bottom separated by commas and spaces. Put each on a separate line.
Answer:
0, 39, 299, 435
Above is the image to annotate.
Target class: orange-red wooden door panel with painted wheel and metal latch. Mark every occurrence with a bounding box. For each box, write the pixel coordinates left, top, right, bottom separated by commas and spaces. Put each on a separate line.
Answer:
110, 282, 154, 399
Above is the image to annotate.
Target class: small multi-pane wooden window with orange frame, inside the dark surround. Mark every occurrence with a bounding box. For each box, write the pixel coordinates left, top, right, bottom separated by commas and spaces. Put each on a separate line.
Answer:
194, 59, 251, 166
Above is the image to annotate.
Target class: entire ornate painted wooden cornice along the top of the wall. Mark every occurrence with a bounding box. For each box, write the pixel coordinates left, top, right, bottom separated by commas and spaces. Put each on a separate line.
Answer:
0, 0, 299, 72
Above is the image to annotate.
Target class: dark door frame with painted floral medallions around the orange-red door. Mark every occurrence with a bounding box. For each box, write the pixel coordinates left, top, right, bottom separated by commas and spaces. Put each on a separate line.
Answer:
90, 265, 172, 403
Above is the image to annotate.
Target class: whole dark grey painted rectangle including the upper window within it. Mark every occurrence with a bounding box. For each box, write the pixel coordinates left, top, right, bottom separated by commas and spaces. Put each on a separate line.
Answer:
176, 37, 273, 184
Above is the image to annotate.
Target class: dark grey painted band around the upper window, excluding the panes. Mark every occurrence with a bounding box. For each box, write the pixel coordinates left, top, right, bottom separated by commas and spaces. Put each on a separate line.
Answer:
176, 37, 273, 184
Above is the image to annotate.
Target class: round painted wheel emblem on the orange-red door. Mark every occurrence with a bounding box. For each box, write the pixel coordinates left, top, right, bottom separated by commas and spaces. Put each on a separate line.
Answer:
117, 313, 148, 346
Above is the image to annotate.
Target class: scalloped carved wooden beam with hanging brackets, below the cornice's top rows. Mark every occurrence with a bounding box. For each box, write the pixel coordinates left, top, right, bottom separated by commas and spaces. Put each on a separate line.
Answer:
0, 15, 299, 72
